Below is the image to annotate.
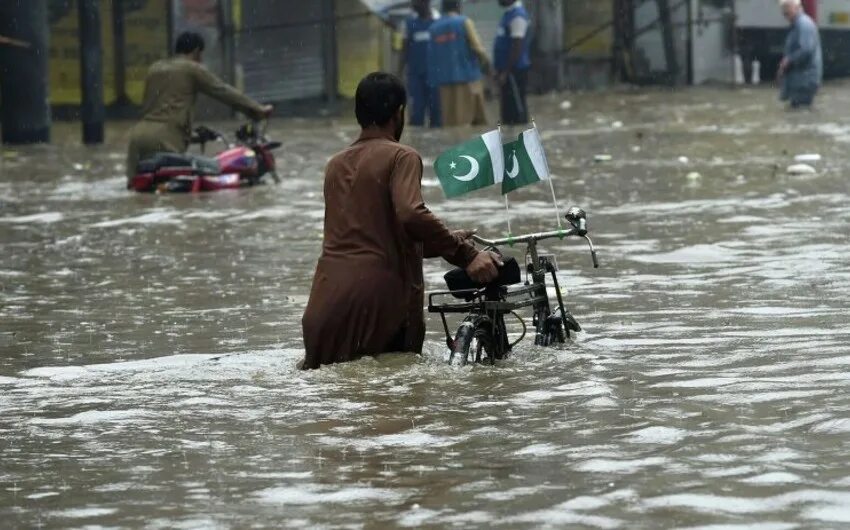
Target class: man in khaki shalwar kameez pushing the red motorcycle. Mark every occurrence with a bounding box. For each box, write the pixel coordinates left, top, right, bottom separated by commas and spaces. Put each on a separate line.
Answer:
127, 32, 272, 179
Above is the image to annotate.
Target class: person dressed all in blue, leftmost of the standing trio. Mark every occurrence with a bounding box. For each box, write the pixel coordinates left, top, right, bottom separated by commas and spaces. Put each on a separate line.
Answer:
401, 0, 442, 127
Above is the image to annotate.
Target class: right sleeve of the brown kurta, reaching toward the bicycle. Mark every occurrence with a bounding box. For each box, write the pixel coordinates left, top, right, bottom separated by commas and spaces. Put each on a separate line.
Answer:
390, 151, 478, 268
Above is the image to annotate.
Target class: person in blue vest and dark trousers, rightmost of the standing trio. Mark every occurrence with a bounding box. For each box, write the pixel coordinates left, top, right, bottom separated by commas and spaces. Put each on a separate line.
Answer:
493, 0, 531, 125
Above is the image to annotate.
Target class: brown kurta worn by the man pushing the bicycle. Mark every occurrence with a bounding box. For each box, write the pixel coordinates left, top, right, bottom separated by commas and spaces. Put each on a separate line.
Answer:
302, 130, 477, 369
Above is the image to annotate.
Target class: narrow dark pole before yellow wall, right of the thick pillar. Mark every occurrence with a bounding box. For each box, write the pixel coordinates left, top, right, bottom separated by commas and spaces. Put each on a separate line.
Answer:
77, 0, 105, 145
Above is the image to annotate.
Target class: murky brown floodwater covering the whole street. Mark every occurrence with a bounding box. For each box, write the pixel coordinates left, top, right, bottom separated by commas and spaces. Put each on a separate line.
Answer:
0, 84, 850, 530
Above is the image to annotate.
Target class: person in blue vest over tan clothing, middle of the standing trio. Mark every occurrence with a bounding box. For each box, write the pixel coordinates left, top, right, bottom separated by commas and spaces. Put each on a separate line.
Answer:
428, 0, 490, 127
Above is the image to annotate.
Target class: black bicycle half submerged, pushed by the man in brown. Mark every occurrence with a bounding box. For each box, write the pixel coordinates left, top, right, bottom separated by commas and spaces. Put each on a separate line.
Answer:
428, 207, 599, 365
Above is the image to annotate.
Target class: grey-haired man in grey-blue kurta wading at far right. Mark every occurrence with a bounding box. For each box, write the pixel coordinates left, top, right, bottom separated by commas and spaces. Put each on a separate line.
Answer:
778, 0, 823, 109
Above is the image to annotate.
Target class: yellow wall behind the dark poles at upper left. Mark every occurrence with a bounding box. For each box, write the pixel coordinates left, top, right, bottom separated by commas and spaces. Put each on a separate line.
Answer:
50, 0, 168, 105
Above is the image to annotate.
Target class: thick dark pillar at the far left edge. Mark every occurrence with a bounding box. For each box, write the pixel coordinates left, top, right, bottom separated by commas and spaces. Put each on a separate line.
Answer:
0, 0, 50, 144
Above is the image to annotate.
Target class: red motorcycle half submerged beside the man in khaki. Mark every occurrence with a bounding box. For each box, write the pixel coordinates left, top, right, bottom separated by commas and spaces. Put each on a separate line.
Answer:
127, 123, 281, 193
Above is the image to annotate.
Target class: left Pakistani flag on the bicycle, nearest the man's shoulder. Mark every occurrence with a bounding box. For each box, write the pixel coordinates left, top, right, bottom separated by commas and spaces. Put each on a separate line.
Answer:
434, 130, 505, 199
